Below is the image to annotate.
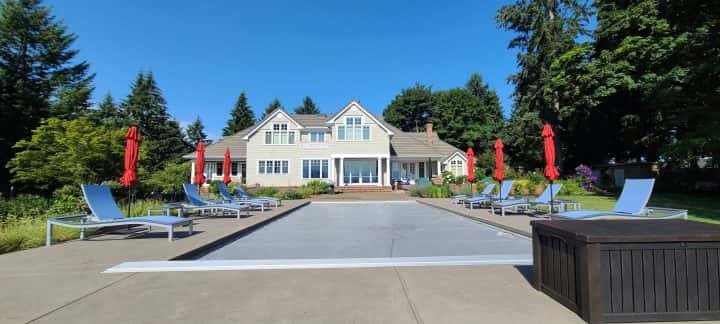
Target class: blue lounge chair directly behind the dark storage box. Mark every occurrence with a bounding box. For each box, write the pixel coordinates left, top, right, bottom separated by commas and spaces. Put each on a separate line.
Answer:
550, 179, 687, 220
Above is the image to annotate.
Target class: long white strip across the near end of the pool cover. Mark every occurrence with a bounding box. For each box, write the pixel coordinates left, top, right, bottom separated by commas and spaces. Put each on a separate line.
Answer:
103, 254, 533, 273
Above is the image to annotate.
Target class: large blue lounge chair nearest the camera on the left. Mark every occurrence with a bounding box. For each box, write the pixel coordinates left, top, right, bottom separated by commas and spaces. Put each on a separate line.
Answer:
45, 185, 192, 246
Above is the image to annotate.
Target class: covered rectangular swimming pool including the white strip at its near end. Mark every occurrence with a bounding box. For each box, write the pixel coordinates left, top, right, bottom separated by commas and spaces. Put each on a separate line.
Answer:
108, 201, 532, 272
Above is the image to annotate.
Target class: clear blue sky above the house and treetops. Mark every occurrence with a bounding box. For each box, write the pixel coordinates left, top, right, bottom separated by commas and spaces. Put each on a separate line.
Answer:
46, 0, 516, 139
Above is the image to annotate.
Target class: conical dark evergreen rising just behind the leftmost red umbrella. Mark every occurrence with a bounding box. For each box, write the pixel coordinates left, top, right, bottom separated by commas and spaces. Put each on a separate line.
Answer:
122, 73, 190, 171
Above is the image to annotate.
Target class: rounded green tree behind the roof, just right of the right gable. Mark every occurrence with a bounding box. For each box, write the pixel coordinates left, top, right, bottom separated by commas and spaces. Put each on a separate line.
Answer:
383, 83, 432, 132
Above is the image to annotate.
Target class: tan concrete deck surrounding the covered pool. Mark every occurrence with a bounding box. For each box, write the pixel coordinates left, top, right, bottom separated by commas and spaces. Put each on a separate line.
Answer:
0, 193, 696, 323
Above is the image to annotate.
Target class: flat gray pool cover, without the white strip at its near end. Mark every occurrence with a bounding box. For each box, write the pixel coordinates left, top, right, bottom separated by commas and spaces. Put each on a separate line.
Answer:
199, 202, 531, 260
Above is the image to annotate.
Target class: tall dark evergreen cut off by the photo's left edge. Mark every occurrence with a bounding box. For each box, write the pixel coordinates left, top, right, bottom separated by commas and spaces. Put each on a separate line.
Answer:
0, 0, 92, 191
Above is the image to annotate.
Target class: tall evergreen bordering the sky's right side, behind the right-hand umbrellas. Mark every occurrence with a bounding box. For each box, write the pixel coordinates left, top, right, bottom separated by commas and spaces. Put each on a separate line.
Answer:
495, 0, 591, 168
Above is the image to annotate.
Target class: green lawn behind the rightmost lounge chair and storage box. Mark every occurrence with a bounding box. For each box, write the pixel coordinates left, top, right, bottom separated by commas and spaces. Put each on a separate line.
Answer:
560, 193, 720, 224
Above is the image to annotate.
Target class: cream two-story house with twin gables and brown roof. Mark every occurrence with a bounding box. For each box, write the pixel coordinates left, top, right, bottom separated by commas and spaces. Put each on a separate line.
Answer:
185, 101, 467, 190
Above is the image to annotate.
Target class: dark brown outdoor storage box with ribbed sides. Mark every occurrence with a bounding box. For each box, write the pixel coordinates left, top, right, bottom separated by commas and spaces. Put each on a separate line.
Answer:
531, 220, 720, 323
